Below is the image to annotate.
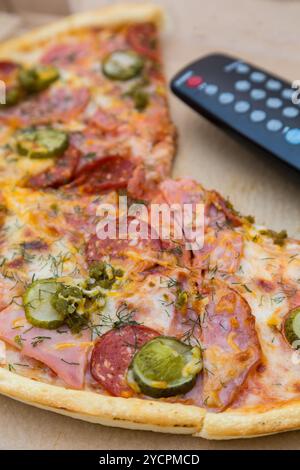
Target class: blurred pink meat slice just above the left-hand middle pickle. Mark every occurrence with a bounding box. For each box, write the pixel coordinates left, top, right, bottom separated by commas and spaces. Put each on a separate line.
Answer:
0, 87, 89, 125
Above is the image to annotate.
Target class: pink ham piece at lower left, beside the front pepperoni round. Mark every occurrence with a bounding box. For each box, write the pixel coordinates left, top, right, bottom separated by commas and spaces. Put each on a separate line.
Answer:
0, 304, 91, 389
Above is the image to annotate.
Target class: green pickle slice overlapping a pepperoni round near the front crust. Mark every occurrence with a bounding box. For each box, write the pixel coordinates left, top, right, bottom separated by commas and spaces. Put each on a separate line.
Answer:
128, 336, 202, 398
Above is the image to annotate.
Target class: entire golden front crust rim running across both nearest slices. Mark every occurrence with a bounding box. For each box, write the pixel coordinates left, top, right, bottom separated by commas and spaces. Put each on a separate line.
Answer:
0, 368, 300, 440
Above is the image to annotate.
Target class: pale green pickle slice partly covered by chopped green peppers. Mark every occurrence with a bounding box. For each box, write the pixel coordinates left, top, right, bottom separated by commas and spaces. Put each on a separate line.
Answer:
23, 279, 65, 330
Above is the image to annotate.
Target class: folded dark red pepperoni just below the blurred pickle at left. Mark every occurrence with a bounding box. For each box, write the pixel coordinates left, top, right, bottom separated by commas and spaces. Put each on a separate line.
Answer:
26, 147, 80, 188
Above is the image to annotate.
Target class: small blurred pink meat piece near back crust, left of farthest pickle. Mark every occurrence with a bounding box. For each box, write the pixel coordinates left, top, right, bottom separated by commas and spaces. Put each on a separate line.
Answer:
41, 43, 88, 66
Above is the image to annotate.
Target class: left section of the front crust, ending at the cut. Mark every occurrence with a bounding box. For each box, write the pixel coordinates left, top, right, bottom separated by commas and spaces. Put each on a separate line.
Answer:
0, 368, 205, 434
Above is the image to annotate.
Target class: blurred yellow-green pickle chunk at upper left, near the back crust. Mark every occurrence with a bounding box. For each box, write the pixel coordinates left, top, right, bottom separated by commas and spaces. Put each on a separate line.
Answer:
19, 65, 59, 93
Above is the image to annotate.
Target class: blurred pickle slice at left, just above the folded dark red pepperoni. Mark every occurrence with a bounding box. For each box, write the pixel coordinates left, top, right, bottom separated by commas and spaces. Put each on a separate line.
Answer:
16, 128, 69, 158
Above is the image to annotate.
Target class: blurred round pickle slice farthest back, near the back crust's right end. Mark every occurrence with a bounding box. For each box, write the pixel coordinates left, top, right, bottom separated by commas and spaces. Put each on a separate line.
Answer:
102, 51, 144, 81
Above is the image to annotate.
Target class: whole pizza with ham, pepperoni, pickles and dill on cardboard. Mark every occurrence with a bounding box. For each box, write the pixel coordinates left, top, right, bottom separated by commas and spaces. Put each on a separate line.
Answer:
0, 5, 300, 439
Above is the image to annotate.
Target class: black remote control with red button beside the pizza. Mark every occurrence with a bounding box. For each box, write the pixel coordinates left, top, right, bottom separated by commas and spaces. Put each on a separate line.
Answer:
171, 54, 300, 170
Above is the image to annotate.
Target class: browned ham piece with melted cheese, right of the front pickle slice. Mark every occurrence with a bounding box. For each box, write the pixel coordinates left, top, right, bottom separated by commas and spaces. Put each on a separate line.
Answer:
201, 281, 261, 411
